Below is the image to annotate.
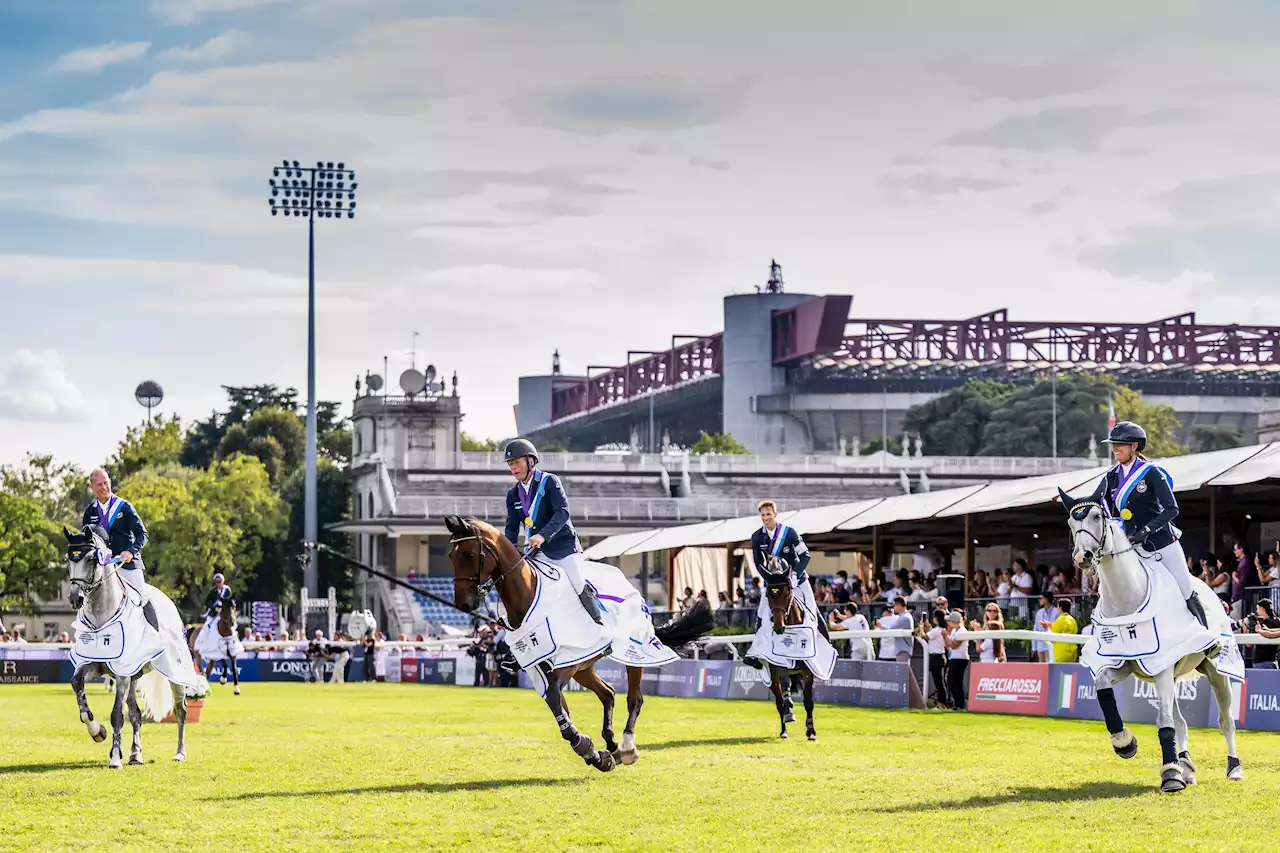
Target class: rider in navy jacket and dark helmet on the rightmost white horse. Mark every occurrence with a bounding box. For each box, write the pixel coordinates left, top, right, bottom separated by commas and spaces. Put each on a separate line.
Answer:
1093, 421, 1208, 628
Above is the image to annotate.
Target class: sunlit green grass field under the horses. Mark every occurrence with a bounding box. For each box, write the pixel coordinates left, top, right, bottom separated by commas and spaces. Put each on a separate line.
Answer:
0, 683, 1280, 853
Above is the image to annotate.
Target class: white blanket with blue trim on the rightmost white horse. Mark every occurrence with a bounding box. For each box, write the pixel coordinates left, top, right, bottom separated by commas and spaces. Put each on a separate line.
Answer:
1080, 558, 1244, 681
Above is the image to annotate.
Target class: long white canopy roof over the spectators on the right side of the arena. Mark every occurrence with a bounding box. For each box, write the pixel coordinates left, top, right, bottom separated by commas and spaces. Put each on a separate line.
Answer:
586, 442, 1280, 560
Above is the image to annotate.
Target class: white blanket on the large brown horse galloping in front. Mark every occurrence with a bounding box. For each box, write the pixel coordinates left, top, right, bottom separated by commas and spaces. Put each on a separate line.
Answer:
498, 558, 680, 695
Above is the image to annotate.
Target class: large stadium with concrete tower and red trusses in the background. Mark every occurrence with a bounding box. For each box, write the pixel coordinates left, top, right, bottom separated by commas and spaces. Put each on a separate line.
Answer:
516, 264, 1280, 455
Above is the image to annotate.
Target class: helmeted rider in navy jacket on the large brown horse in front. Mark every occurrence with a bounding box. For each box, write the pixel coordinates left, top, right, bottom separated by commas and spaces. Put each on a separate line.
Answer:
503, 438, 603, 625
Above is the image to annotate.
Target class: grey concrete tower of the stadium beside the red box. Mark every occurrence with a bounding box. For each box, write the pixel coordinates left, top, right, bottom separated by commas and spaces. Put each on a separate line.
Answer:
722, 293, 813, 453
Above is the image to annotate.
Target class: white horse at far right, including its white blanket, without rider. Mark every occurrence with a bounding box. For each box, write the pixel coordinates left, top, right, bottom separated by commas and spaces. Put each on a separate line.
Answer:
1059, 489, 1244, 793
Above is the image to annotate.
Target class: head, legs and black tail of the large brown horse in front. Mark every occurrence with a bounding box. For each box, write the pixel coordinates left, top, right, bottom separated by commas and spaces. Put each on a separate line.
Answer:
444, 515, 714, 772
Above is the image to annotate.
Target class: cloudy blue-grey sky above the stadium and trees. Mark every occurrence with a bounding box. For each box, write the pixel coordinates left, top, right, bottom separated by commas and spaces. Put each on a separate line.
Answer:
0, 0, 1280, 464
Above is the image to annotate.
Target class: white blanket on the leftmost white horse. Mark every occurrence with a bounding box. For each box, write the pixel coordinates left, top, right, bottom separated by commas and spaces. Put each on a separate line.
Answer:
70, 584, 197, 690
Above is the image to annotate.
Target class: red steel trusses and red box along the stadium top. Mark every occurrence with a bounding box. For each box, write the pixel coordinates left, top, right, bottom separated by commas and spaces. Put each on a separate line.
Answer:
552, 296, 1280, 423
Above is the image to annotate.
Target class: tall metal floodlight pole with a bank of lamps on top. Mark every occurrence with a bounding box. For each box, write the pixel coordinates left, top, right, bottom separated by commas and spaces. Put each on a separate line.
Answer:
268, 160, 356, 591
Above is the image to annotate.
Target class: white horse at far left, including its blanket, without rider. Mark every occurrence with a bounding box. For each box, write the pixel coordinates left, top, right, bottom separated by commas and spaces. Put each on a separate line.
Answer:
63, 526, 197, 768
